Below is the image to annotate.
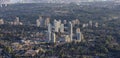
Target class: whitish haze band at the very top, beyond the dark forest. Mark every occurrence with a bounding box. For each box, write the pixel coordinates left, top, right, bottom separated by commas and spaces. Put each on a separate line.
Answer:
0, 0, 120, 4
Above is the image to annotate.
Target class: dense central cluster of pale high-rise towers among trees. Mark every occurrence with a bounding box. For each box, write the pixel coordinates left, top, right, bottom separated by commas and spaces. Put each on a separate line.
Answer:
45, 19, 83, 43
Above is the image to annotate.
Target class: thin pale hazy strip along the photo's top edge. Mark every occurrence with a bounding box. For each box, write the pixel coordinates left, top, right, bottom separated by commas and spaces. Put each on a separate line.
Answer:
0, 0, 118, 3
